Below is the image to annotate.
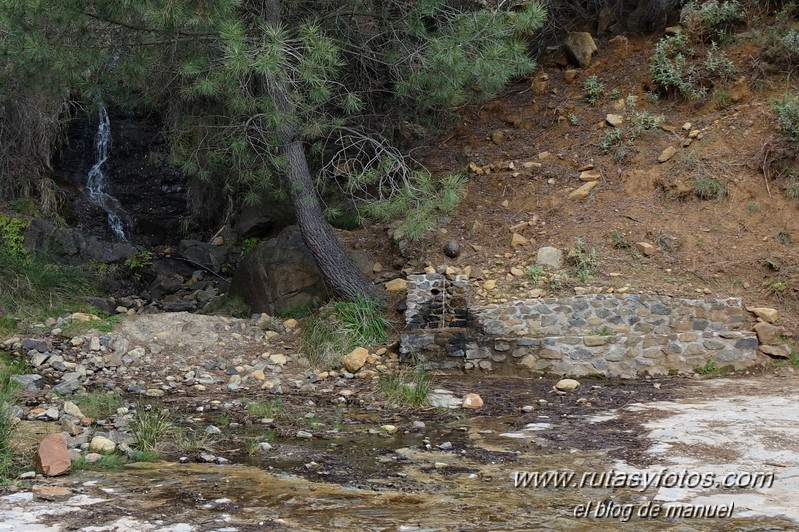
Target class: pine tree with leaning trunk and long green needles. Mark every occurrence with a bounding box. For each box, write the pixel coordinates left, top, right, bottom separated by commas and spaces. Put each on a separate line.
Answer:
0, 0, 544, 298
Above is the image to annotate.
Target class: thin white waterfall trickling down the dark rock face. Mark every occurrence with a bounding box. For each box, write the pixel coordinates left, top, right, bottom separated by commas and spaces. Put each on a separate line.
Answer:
86, 105, 128, 241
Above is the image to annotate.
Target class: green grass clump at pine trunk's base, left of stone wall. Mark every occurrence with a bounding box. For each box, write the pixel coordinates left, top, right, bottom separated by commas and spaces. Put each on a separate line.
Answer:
302, 299, 390, 368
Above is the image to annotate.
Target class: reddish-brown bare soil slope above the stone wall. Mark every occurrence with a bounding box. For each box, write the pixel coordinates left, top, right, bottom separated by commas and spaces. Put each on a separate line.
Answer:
351, 30, 799, 329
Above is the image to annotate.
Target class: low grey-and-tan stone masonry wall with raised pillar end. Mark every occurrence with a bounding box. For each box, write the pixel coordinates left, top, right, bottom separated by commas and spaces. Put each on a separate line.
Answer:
400, 274, 758, 378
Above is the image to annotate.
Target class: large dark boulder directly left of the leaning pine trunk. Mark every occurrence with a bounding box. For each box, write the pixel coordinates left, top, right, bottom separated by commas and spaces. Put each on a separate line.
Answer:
232, 225, 331, 314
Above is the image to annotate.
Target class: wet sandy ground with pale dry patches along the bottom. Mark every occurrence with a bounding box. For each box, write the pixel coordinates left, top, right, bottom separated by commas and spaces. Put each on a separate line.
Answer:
6, 375, 799, 531
